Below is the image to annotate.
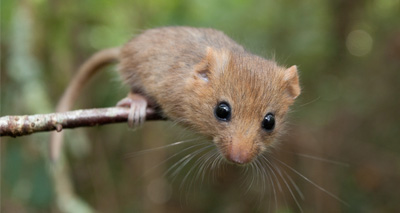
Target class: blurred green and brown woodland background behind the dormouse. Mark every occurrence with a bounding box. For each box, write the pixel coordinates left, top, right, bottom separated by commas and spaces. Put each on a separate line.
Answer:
1, 0, 400, 212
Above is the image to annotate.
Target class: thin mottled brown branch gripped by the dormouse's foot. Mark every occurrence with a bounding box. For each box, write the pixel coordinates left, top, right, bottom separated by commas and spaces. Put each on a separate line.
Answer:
0, 107, 164, 137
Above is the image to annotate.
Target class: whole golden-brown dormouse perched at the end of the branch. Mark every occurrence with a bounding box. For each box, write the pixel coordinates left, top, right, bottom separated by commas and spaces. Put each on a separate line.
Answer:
52, 27, 300, 164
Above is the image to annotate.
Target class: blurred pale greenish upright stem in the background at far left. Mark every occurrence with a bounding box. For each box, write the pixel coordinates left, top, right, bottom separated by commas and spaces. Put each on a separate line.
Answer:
8, 1, 92, 212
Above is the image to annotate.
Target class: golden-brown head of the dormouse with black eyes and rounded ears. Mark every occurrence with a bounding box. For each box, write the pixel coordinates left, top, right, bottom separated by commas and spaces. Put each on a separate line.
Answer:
186, 47, 300, 164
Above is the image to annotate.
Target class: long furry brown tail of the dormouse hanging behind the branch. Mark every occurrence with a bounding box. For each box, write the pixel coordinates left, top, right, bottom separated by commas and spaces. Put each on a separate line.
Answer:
50, 47, 120, 161
